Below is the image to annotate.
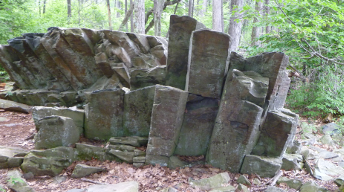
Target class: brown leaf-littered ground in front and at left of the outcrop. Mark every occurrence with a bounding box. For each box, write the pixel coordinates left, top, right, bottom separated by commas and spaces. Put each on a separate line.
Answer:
0, 111, 338, 192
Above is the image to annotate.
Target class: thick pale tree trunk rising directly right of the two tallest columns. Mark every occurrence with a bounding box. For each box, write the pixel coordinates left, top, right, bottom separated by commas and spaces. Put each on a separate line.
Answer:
228, 0, 244, 51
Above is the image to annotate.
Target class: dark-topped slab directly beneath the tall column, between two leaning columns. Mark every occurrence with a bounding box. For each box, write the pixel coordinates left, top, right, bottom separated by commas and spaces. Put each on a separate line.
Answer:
174, 94, 219, 156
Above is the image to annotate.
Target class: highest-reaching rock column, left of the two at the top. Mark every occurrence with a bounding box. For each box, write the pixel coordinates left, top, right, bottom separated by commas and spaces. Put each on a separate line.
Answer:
166, 15, 206, 90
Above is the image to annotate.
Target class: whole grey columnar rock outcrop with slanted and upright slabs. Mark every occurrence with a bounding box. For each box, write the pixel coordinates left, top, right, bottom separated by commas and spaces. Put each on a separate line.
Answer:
0, 15, 298, 176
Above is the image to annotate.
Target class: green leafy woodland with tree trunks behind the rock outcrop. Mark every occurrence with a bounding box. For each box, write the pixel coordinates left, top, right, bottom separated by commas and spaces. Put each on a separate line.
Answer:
0, 0, 344, 123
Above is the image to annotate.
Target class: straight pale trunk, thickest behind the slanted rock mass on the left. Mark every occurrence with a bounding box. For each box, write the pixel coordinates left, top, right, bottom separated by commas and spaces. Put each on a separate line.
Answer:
134, 0, 145, 34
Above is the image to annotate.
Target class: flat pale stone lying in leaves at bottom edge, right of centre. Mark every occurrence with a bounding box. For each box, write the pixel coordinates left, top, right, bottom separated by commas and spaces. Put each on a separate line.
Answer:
190, 172, 230, 191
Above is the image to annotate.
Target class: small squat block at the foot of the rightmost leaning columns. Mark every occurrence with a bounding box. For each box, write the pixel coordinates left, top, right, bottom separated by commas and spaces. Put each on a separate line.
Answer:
240, 155, 282, 177
